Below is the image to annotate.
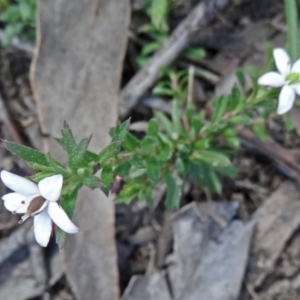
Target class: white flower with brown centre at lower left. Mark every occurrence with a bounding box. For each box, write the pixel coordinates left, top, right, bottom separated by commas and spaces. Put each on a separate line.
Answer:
1, 171, 78, 247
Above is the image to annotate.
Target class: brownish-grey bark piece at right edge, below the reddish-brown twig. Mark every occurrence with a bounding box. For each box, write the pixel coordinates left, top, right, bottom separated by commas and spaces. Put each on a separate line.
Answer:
246, 181, 300, 288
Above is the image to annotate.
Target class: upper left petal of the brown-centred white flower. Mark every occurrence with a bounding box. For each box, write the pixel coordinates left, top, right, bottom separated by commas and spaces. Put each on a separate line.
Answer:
1, 170, 39, 196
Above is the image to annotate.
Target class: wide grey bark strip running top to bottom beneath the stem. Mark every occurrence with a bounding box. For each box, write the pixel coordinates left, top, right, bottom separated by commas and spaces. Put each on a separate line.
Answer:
31, 0, 130, 300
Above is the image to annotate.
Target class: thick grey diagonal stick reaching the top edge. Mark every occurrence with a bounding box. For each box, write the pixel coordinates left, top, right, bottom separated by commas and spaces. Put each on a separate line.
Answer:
119, 0, 229, 117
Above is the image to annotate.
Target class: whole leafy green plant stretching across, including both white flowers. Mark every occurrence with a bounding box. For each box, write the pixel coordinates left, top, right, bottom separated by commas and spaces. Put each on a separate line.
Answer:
1, 0, 300, 246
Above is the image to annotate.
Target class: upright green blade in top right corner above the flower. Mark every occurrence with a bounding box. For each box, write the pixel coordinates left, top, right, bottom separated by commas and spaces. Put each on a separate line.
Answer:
284, 0, 298, 62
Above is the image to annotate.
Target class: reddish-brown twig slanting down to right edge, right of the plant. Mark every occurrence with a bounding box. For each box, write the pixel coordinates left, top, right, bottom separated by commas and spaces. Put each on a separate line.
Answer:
240, 129, 300, 183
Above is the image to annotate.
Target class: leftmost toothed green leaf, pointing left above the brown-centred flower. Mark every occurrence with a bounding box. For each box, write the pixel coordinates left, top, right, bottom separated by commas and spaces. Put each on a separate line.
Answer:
3, 141, 51, 168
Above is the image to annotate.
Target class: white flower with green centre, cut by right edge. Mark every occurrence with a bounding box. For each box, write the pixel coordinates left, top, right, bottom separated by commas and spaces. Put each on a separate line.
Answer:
258, 48, 300, 114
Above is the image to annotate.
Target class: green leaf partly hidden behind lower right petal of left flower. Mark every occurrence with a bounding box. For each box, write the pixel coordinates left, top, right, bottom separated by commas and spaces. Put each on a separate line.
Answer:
56, 183, 81, 249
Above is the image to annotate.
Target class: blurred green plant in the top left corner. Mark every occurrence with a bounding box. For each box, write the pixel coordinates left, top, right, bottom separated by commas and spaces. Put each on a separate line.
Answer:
0, 0, 35, 46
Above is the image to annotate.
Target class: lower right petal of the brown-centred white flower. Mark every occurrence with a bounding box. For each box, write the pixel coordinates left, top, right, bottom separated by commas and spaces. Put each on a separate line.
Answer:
48, 202, 79, 233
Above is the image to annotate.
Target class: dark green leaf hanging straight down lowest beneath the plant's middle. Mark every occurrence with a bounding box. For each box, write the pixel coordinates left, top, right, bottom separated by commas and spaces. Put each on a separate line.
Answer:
165, 172, 182, 210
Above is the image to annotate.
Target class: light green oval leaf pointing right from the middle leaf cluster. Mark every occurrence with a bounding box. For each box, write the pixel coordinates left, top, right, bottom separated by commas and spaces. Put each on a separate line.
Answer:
192, 150, 231, 167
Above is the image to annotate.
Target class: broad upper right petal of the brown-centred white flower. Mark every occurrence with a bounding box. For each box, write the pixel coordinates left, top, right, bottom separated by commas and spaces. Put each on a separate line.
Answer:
39, 174, 63, 201
